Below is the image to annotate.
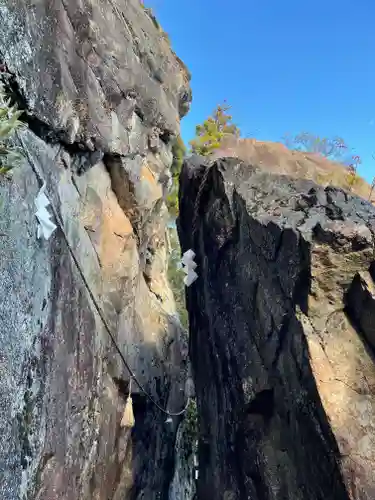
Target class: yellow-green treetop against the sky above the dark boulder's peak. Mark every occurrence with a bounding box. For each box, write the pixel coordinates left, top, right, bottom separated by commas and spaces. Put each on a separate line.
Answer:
190, 104, 240, 156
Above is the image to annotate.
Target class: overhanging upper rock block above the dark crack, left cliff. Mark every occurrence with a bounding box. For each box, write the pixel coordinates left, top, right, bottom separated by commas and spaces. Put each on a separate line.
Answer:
0, 0, 190, 150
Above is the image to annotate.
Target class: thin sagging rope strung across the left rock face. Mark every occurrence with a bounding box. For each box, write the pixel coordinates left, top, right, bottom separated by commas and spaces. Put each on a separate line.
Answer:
16, 131, 190, 417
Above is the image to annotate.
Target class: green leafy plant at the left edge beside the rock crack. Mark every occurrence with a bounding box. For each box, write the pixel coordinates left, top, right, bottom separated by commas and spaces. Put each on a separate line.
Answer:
0, 84, 24, 174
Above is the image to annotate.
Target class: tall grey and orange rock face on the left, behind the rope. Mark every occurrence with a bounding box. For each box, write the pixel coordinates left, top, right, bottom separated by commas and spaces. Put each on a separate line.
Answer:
0, 0, 190, 500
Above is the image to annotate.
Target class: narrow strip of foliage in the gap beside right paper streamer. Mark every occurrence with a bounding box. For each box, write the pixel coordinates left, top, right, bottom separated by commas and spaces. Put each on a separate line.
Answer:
168, 227, 188, 329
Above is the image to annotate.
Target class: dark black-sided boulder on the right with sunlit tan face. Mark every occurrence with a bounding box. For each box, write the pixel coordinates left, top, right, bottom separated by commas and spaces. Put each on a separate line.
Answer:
179, 157, 375, 500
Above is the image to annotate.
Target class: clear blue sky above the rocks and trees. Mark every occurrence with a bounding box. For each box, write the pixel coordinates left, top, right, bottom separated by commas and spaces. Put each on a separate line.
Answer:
145, 0, 375, 180
